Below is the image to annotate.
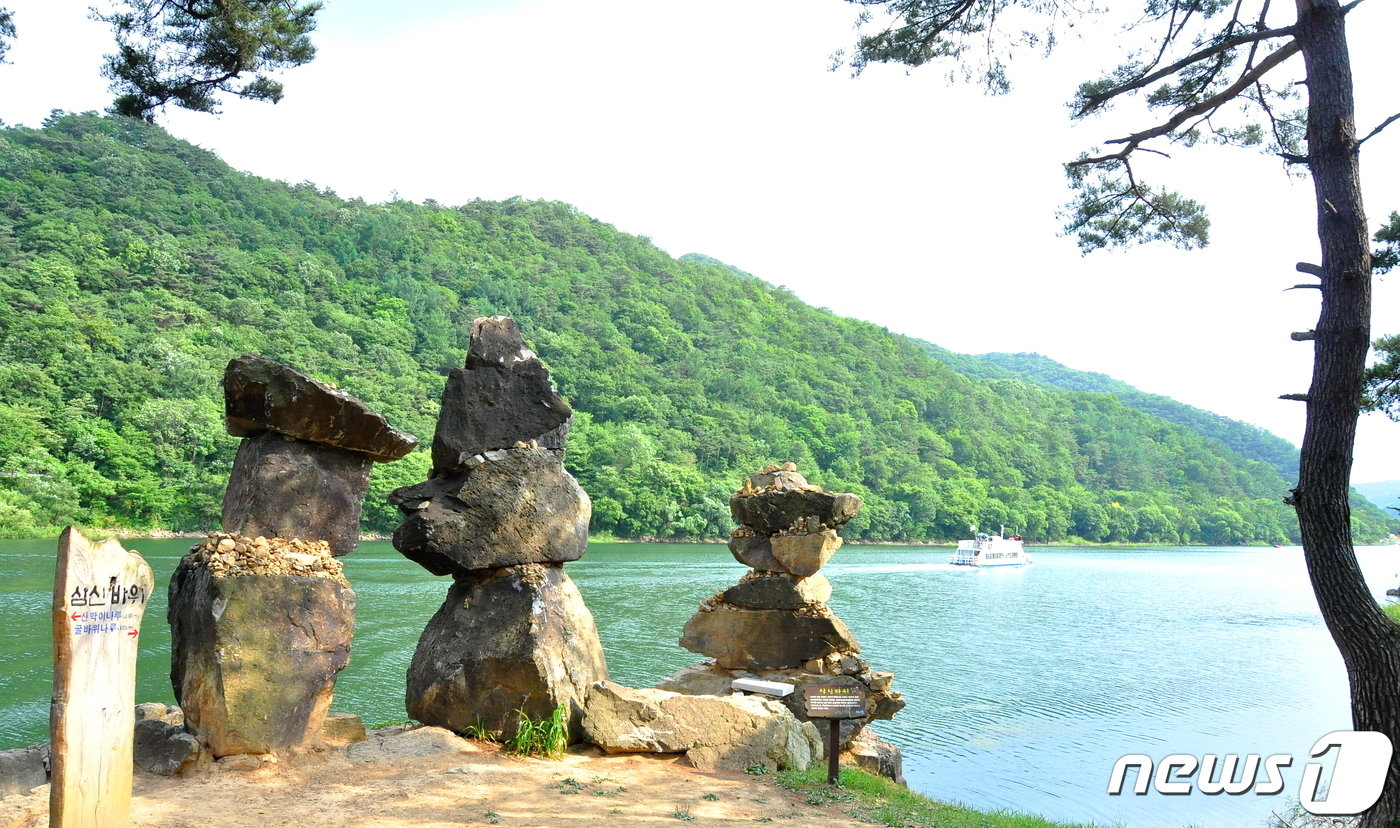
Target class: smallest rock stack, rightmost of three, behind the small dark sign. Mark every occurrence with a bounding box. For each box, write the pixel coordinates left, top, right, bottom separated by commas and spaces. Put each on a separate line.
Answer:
657, 462, 904, 778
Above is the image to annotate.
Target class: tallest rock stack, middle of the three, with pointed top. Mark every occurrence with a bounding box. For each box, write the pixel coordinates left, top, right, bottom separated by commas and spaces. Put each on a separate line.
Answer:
389, 317, 608, 737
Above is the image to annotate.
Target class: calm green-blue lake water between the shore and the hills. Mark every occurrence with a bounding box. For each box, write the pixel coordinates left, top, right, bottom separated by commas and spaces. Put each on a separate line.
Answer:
0, 539, 1400, 828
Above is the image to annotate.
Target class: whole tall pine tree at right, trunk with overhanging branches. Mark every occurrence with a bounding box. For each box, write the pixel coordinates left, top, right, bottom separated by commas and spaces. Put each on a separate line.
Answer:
848, 0, 1400, 825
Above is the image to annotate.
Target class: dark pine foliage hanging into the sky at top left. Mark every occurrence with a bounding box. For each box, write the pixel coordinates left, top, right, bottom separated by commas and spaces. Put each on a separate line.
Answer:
0, 0, 321, 120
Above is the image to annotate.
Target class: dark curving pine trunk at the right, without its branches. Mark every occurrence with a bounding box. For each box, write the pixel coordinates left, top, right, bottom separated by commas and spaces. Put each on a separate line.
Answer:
1292, 0, 1400, 827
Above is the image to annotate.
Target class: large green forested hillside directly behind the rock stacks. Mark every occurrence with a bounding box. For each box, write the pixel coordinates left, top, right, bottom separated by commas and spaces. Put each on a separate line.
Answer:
0, 115, 1397, 544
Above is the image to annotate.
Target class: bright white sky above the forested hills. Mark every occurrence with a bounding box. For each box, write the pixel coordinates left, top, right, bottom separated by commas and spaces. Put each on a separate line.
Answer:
8, 0, 1400, 482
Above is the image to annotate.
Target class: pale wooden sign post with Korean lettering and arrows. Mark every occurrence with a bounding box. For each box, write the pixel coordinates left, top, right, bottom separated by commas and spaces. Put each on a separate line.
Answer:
49, 527, 155, 828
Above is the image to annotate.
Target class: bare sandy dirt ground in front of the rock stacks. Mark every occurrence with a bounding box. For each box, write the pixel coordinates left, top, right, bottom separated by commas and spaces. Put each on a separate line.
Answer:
0, 727, 862, 828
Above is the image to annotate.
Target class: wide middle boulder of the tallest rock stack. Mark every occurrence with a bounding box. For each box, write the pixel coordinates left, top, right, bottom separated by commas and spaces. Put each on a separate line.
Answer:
389, 448, 592, 574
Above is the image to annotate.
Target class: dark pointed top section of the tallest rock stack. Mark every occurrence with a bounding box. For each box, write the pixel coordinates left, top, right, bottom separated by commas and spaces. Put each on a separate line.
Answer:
433, 317, 574, 476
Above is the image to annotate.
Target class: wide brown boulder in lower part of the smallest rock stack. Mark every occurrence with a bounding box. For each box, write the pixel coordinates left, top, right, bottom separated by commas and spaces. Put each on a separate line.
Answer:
680, 602, 860, 670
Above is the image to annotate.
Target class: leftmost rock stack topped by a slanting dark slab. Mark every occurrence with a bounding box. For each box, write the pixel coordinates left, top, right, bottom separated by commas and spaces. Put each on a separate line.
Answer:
168, 354, 417, 758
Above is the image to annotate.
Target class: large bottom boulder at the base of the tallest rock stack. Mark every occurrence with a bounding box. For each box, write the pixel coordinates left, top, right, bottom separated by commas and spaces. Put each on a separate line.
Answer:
407, 563, 608, 738
